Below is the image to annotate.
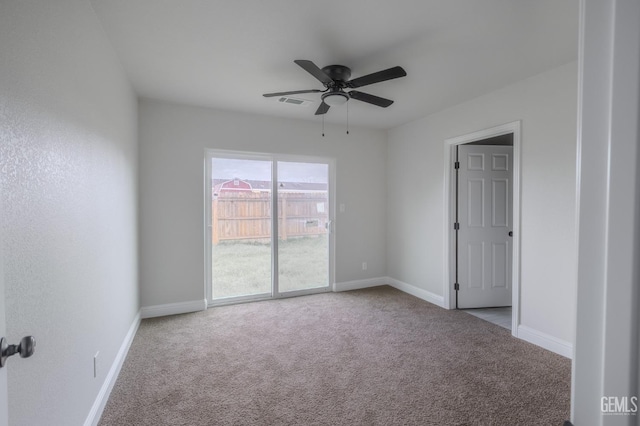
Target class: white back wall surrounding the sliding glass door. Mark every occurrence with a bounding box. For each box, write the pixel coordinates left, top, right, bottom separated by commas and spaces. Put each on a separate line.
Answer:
139, 99, 387, 307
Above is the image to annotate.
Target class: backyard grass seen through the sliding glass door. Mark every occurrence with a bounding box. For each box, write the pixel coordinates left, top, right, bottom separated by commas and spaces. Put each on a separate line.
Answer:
212, 235, 329, 299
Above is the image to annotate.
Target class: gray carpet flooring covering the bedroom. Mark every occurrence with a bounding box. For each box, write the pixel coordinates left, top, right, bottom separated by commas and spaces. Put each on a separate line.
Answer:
100, 286, 571, 426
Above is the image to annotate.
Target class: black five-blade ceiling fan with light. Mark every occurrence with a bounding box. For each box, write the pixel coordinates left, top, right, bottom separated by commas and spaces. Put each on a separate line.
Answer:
263, 59, 407, 115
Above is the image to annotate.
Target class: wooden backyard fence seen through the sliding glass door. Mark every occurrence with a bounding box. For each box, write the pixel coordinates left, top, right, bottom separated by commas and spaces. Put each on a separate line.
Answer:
211, 191, 329, 244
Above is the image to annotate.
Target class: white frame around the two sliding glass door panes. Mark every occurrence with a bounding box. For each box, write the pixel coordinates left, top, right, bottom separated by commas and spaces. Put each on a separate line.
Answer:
203, 149, 336, 307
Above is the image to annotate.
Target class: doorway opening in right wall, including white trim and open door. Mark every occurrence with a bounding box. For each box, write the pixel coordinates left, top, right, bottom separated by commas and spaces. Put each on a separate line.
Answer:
444, 122, 520, 336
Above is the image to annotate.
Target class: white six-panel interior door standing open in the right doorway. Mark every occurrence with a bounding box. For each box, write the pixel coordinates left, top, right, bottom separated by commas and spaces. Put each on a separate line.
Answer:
458, 145, 513, 308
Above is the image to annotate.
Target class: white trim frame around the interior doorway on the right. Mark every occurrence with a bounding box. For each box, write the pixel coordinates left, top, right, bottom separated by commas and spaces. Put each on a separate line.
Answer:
443, 121, 522, 337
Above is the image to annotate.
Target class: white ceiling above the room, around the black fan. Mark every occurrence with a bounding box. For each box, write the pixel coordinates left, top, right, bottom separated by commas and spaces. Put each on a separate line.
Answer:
92, 0, 578, 129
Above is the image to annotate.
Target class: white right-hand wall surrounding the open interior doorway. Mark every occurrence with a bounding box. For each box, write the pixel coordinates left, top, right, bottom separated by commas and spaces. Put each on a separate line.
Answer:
387, 63, 577, 352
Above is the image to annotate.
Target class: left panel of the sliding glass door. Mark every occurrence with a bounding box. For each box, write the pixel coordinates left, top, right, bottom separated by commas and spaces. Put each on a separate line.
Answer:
210, 157, 273, 300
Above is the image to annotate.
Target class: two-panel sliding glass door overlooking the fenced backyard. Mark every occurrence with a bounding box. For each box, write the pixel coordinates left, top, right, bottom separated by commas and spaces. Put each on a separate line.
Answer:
206, 151, 333, 305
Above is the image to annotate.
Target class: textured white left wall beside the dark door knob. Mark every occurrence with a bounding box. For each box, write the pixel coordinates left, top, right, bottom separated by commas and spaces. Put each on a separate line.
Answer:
0, 0, 139, 426
